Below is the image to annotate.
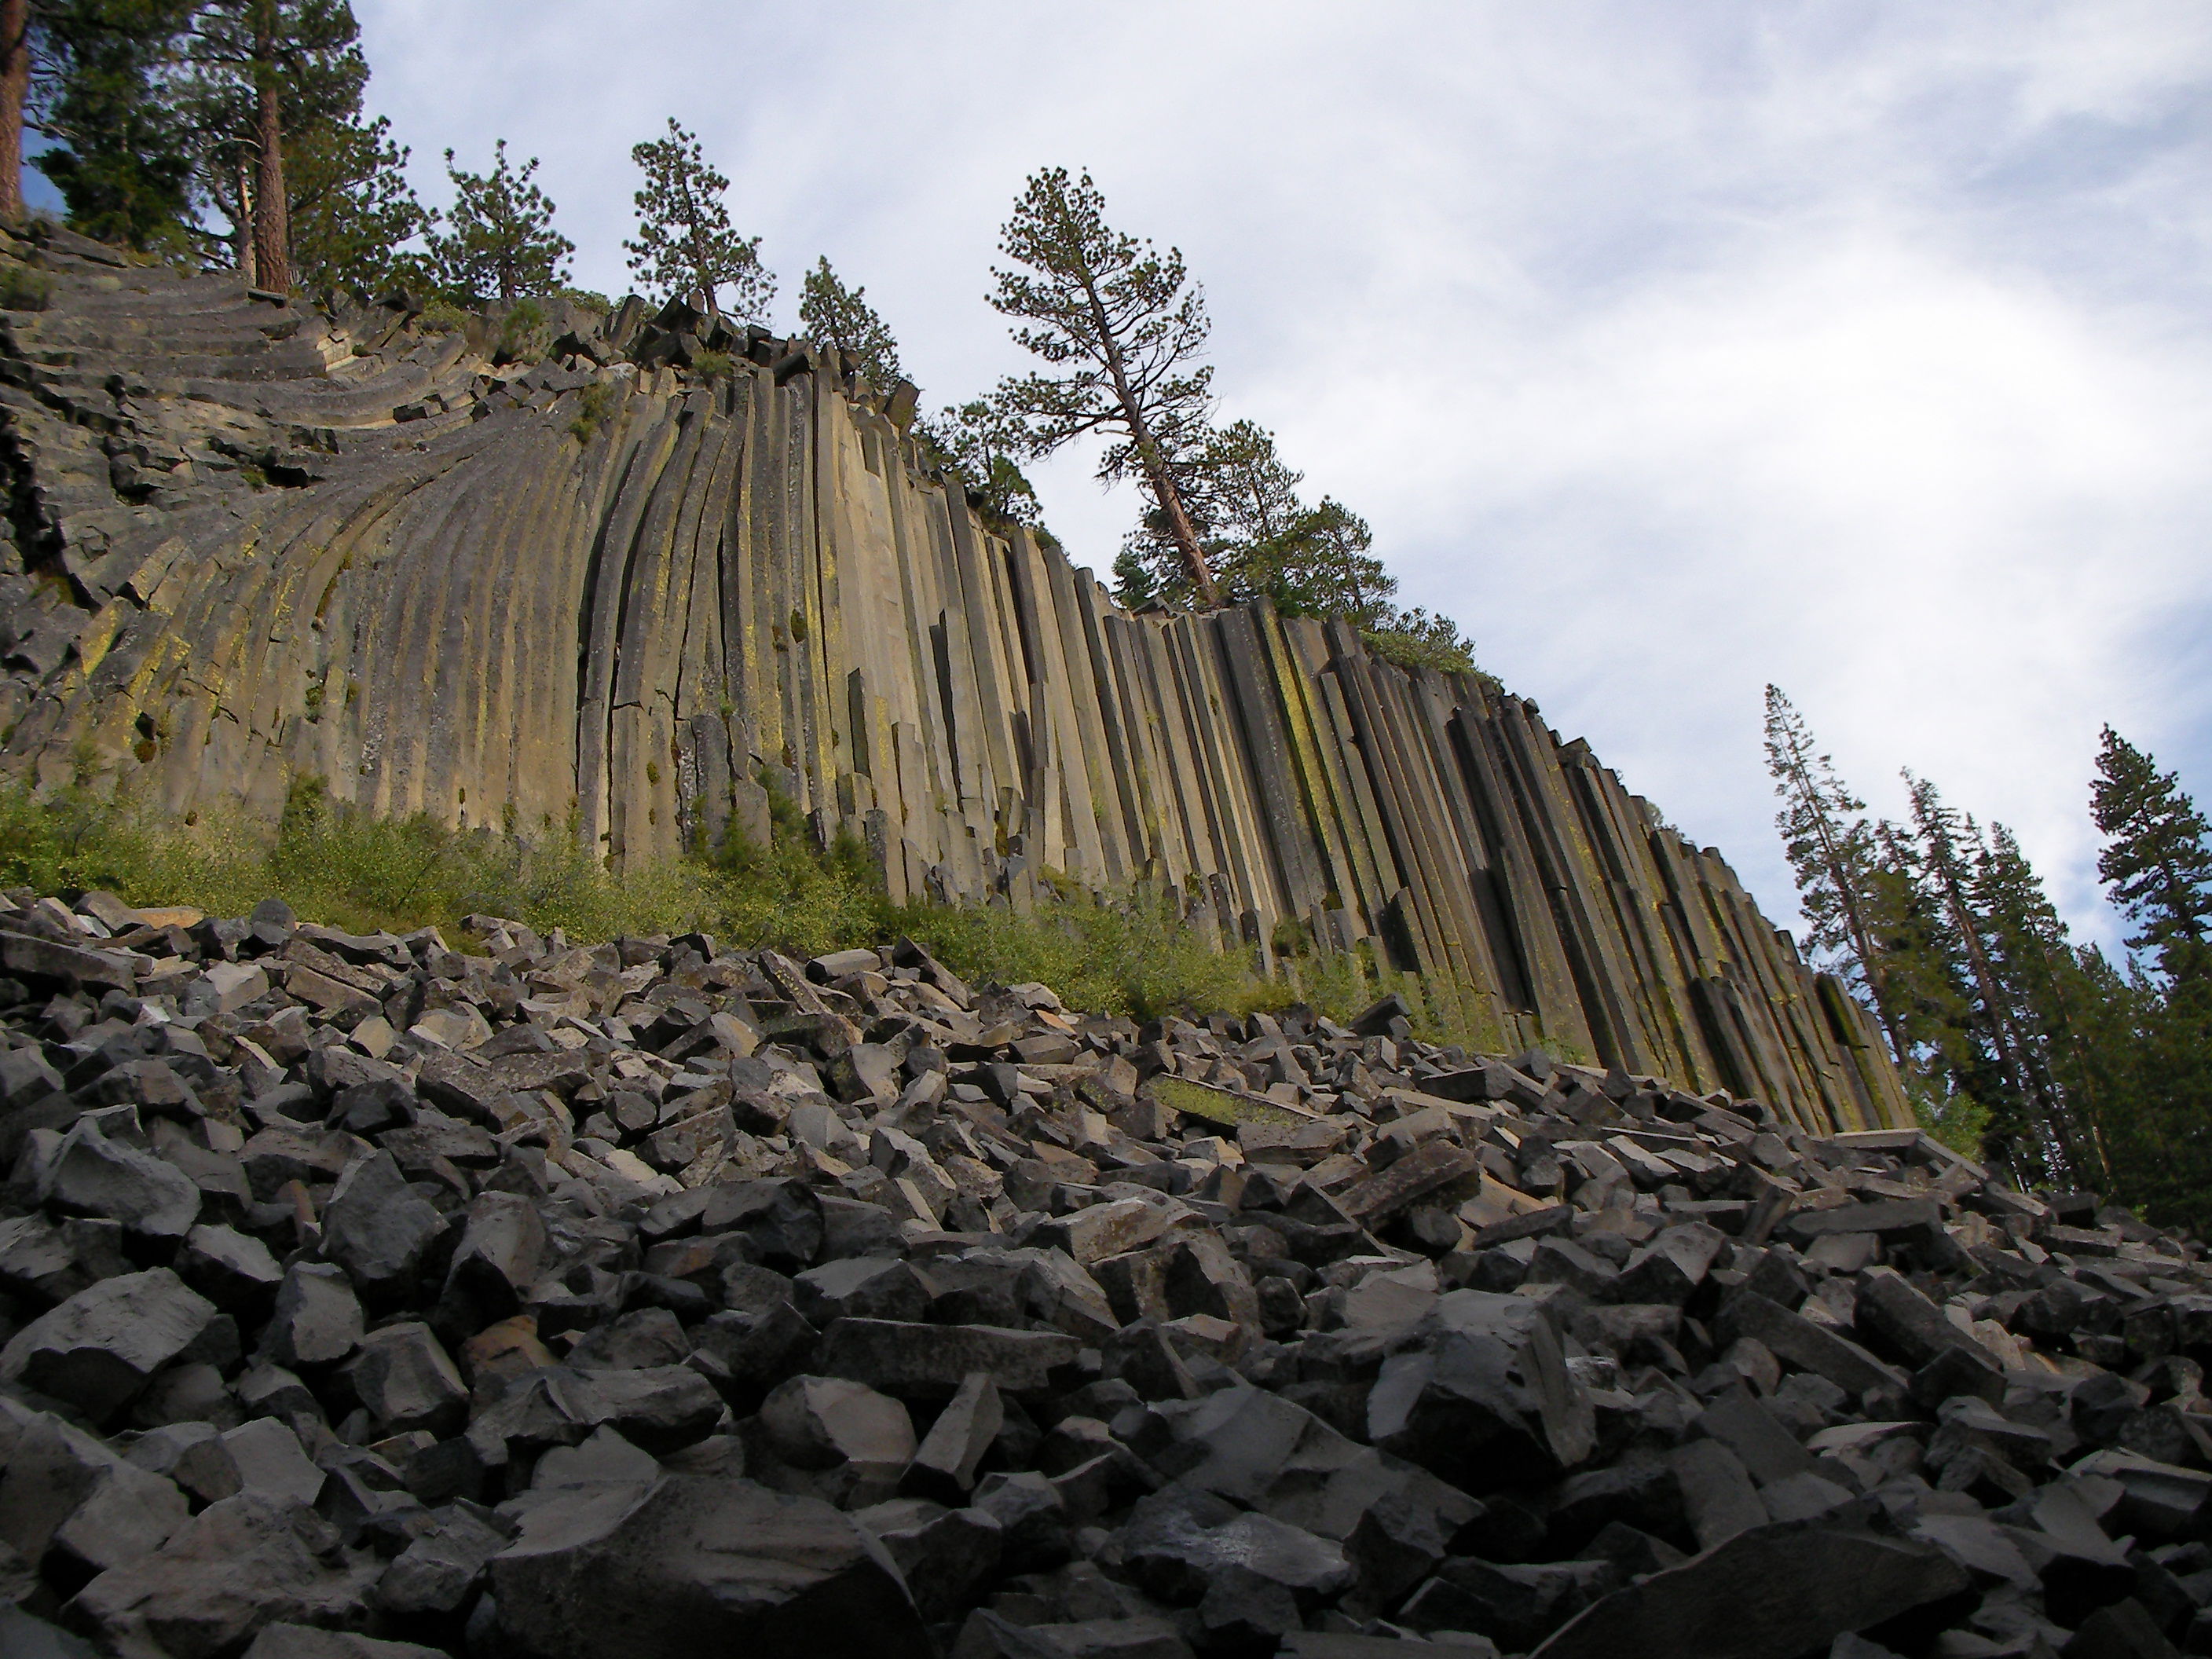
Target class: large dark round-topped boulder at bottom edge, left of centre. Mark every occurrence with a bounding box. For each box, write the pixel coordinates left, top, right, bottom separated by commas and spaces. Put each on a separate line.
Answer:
491, 1475, 932, 1659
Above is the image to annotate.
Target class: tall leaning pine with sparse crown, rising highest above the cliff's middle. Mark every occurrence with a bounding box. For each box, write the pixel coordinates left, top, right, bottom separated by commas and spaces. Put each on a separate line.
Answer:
989, 168, 1221, 608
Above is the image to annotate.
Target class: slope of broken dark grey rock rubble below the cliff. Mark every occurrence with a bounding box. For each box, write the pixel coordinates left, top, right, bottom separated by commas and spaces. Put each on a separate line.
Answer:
0, 892, 2212, 1659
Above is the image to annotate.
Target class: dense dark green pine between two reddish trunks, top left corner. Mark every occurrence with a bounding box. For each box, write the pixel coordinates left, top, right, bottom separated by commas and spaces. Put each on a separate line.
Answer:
23, 0, 197, 258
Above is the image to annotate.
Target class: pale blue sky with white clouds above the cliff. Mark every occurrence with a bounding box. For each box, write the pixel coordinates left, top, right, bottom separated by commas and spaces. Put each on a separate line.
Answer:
340, 0, 2212, 955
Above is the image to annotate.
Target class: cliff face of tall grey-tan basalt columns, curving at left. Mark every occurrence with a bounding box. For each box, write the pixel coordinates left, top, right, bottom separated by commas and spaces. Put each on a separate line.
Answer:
0, 234, 1909, 1130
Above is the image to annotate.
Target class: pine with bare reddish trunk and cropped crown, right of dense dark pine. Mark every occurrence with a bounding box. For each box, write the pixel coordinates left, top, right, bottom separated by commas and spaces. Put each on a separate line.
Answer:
186, 0, 369, 292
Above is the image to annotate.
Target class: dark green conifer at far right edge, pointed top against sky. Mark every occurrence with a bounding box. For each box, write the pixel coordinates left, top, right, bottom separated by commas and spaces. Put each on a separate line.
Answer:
2090, 726, 2212, 982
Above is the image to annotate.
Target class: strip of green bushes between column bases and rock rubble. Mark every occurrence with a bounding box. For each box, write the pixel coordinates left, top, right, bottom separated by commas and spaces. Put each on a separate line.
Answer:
0, 778, 1292, 1017
